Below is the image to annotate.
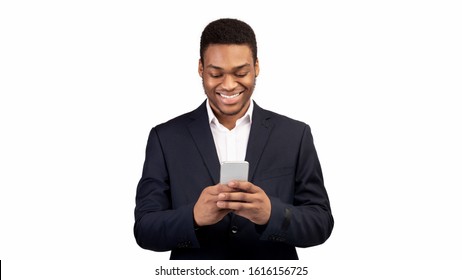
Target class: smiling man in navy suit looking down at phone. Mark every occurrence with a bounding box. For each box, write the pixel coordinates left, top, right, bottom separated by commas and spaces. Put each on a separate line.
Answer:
134, 19, 334, 259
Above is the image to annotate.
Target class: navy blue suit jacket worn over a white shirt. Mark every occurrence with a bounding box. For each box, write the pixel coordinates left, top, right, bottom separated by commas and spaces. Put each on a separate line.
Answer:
134, 99, 334, 259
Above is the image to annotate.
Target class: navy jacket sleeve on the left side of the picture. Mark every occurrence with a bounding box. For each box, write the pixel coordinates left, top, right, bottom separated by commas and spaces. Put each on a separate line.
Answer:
134, 128, 199, 251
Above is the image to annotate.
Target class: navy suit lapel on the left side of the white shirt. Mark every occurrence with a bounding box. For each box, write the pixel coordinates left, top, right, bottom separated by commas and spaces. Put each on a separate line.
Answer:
188, 102, 220, 184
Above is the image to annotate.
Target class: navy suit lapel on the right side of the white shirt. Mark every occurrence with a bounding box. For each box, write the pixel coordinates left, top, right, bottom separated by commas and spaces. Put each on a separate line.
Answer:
245, 102, 273, 182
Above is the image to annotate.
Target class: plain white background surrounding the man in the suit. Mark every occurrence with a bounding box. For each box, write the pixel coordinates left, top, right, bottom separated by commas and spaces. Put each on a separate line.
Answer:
0, 0, 462, 279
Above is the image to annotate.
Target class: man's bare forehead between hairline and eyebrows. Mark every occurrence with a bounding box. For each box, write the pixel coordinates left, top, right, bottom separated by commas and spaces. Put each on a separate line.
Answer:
204, 44, 253, 68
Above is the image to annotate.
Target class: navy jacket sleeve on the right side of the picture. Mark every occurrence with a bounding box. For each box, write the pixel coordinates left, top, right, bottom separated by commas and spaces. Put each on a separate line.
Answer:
261, 125, 334, 247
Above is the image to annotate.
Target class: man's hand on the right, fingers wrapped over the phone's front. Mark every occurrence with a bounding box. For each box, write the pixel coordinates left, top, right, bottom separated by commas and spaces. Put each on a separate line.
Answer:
216, 181, 271, 225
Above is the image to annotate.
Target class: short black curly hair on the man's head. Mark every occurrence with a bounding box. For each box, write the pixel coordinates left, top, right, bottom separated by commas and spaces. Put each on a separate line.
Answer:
200, 18, 257, 63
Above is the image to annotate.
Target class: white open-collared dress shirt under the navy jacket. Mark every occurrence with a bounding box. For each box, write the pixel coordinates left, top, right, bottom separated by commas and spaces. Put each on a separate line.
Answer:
207, 99, 253, 162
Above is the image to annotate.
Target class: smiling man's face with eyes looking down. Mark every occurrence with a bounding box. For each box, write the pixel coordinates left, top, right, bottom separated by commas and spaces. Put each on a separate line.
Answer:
199, 44, 259, 127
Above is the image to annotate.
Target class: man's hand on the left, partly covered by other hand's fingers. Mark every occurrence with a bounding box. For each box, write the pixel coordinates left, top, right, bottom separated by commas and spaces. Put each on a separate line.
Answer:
193, 184, 234, 226
